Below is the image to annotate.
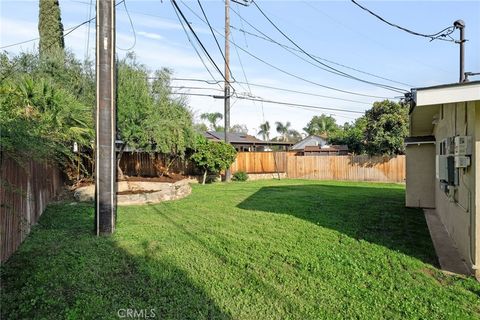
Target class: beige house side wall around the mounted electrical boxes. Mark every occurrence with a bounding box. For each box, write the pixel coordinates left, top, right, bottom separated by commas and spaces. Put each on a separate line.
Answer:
433, 102, 480, 276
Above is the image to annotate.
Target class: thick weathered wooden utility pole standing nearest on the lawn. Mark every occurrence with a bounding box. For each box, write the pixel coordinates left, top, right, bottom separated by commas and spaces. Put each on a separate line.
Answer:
95, 0, 117, 235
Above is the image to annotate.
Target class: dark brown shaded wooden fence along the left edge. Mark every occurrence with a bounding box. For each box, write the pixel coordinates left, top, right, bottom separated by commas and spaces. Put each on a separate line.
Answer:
0, 153, 63, 262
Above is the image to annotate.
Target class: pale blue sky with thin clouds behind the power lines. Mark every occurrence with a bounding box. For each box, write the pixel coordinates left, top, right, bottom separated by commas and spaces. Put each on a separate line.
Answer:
0, 0, 480, 136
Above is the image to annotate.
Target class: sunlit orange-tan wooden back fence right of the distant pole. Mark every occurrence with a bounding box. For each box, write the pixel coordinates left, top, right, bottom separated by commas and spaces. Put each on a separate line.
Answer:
231, 152, 405, 182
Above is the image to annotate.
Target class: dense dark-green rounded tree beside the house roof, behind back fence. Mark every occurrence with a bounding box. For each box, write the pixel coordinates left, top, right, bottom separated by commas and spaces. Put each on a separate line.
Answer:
365, 100, 408, 155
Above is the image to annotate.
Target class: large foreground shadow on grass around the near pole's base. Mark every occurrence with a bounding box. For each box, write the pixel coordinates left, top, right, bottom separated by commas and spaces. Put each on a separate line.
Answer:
1, 205, 231, 319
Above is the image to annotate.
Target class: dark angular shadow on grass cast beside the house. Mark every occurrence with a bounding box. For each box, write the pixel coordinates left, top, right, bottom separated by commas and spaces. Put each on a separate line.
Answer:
238, 184, 438, 266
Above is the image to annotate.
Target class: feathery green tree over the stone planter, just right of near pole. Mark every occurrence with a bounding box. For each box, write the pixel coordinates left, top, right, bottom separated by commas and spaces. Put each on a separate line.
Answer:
117, 54, 194, 176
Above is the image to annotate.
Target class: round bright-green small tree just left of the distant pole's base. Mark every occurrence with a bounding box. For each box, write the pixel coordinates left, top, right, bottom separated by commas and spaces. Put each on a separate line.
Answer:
190, 135, 237, 184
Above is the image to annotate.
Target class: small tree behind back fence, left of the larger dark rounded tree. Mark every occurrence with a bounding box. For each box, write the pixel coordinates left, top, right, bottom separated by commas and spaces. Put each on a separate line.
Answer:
328, 116, 367, 154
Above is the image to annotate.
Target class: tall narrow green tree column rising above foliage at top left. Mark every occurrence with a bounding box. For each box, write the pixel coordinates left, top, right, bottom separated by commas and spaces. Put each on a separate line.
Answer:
38, 0, 65, 56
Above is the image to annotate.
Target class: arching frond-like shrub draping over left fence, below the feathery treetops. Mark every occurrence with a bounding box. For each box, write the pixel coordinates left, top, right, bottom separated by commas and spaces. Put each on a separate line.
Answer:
0, 75, 93, 173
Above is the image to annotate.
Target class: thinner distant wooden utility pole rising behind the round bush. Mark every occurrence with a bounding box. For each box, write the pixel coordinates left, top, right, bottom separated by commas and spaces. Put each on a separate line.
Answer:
223, 0, 231, 182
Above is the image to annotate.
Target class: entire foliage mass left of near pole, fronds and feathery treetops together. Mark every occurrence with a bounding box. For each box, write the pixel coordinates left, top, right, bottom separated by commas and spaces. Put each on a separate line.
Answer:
0, 52, 95, 177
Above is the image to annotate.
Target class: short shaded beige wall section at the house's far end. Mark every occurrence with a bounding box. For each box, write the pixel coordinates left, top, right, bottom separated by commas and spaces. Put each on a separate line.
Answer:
405, 143, 436, 208
